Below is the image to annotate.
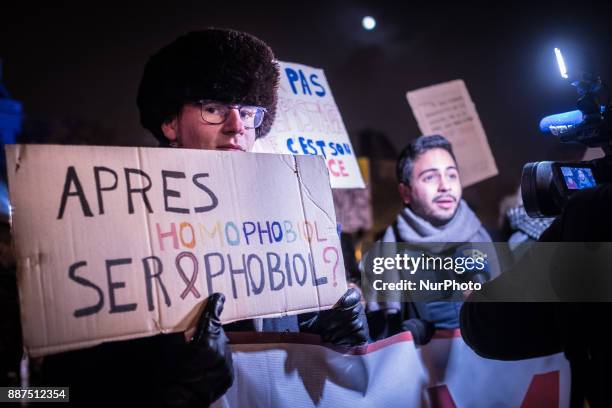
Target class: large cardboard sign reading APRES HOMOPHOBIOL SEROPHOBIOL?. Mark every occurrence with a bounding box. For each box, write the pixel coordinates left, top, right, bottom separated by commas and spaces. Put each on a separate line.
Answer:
6, 145, 346, 356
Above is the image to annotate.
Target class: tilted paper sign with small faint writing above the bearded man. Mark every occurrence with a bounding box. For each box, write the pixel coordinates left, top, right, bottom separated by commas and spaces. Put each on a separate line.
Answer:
406, 79, 497, 187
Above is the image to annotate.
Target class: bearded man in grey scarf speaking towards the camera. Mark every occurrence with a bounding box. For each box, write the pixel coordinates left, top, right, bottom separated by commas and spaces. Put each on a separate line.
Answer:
368, 135, 499, 344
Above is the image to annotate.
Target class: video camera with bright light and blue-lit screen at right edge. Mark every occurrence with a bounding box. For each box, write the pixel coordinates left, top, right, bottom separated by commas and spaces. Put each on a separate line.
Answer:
521, 48, 612, 218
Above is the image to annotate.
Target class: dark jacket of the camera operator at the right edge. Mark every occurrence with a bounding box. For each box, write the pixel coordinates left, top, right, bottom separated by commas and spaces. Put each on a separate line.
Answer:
461, 185, 612, 407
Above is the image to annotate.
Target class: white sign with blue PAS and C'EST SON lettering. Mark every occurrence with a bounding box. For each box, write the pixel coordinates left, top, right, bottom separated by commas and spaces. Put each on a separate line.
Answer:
255, 61, 364, 188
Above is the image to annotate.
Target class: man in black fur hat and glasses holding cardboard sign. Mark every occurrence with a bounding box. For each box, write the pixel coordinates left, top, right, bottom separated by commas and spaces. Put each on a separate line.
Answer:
45, 29, 368, 406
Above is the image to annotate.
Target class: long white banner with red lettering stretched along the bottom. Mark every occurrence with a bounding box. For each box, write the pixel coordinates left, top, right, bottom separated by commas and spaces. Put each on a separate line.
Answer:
212, 331, 571, 408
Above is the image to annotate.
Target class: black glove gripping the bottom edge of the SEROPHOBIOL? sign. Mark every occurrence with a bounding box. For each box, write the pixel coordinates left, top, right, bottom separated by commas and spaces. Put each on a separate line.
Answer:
164, 293, 234, 407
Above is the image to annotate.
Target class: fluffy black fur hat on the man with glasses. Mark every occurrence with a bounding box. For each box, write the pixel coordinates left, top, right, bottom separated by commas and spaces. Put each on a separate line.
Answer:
136, 28, 279, 145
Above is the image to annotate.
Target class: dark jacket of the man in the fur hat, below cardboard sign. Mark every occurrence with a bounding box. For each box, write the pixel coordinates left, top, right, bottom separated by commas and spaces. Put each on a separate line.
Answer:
36, 316, 298, 407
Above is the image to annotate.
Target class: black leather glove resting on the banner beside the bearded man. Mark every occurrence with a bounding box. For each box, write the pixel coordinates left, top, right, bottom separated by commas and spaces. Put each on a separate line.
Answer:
300, 288, 369, 346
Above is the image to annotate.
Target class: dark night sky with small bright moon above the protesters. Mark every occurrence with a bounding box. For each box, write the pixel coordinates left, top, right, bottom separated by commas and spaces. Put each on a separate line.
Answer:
0, 1, 612, 224
